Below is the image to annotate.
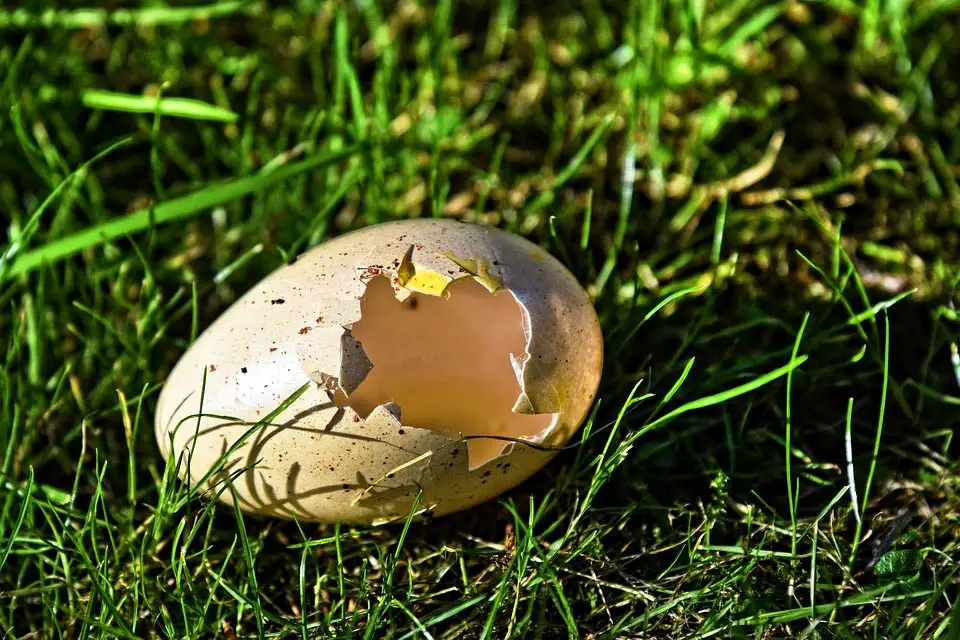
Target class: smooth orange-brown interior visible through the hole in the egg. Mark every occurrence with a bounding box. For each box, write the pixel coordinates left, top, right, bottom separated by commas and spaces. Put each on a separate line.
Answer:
337, 276, 555, 468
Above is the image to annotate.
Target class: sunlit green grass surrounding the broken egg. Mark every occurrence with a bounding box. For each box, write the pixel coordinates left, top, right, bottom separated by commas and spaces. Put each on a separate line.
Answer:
0, 0, 960, 639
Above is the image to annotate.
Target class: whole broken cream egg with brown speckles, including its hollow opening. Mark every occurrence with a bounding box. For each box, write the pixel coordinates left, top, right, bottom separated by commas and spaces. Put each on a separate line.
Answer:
155, 219, 603, 524
